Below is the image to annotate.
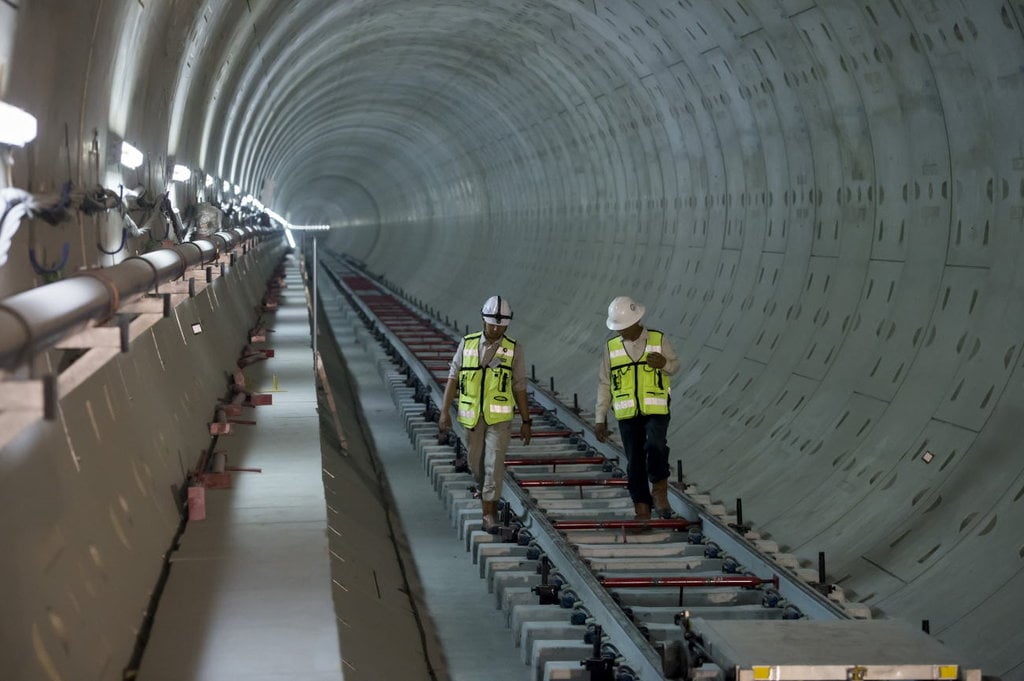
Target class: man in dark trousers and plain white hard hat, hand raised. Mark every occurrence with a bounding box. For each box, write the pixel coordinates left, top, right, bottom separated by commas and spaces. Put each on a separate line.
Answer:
595, 296, 679, 520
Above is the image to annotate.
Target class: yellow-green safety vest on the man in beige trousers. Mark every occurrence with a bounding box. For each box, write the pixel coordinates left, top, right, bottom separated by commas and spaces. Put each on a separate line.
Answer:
459, 333, 515, 428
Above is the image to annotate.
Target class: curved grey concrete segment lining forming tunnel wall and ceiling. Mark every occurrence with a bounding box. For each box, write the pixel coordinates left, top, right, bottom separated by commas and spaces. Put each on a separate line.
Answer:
0, 0, 1024, 678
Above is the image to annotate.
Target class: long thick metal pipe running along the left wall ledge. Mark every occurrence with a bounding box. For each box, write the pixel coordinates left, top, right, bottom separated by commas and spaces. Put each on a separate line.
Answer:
0, 228, 276, 369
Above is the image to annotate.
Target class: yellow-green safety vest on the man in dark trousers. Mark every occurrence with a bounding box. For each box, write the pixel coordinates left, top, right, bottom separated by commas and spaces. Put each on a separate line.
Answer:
608, 329, 671, 421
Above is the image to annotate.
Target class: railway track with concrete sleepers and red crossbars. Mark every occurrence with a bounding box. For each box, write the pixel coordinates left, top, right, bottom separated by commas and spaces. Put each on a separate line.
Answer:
322, 254, 980, 681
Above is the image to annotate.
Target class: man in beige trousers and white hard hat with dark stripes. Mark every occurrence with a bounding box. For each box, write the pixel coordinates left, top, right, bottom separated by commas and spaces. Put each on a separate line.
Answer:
437, 296, 530, 530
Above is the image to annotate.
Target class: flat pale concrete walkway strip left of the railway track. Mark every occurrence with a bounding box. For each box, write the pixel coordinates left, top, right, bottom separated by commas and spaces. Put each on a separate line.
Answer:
138, 258, 342, 681
